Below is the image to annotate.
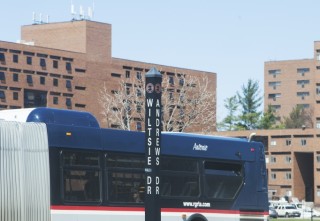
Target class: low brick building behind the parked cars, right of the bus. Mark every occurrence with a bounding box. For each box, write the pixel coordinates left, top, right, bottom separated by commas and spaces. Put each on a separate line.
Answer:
217, 128, 320, 205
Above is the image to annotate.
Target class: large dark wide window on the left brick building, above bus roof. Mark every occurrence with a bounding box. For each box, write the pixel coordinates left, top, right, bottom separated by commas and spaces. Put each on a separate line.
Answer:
24, 90, 47, 108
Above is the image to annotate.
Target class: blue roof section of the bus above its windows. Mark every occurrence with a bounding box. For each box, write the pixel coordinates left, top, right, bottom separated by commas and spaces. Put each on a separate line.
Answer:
0, 108, 262, 161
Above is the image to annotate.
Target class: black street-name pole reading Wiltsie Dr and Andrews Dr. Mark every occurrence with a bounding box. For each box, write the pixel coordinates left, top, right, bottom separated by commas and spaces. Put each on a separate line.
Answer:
144, 68, 162, 221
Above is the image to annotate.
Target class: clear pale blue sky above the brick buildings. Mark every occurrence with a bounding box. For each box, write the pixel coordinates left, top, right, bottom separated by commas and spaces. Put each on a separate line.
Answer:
0, 0, 320, 122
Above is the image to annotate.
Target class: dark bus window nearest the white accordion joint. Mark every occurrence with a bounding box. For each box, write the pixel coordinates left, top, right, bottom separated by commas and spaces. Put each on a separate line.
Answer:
61, 151, 101, 203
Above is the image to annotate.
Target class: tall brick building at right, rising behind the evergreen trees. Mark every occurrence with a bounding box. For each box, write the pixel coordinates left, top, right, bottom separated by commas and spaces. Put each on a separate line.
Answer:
264, 41, 320, 128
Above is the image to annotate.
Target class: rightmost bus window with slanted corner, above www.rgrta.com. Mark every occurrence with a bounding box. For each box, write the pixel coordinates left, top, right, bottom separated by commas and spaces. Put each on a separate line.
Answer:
204, 161, 243, 200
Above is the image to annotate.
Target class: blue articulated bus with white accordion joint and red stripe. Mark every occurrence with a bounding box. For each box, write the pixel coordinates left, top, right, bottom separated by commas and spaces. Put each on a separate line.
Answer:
0, 108, 268, 221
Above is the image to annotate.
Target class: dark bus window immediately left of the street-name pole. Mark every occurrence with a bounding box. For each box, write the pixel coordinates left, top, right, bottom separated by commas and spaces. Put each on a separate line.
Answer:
106, 153, 145, 203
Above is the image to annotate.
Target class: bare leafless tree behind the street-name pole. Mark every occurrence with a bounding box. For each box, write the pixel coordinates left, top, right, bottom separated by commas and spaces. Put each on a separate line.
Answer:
99, 74, 216, 133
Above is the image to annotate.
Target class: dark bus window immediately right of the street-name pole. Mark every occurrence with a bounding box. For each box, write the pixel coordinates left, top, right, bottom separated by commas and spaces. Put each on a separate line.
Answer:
160, 157, 200, 197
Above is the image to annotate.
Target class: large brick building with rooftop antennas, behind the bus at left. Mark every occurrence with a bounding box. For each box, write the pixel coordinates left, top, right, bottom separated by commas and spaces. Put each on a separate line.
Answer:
0, 20, 216, 129
